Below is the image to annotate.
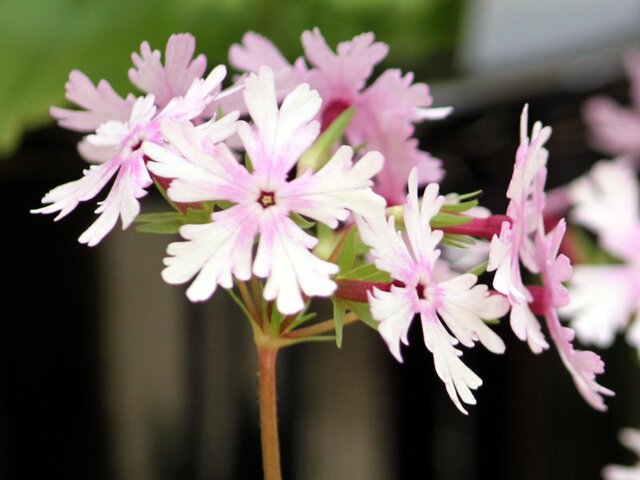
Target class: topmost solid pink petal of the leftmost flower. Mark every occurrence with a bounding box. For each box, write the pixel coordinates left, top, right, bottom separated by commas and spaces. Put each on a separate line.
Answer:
129, 33, 207, 107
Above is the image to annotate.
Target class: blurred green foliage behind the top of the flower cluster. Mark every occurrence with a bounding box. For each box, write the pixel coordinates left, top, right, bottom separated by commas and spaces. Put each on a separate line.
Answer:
0, 0, 465, 157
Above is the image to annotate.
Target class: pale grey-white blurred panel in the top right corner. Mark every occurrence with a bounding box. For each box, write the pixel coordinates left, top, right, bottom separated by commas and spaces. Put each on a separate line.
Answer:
460, 0, 640, 72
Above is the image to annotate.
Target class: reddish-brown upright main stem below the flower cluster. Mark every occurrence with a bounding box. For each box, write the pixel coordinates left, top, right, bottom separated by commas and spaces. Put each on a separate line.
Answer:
258, 345, 282, 480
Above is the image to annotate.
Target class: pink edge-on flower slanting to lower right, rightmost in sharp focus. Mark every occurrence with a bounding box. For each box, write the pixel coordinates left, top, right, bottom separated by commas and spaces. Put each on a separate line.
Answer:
536, 220, 613, 410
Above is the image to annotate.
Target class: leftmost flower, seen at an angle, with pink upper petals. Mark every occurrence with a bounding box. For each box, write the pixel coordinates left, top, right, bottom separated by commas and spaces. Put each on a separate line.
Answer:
32, 35, 226, 246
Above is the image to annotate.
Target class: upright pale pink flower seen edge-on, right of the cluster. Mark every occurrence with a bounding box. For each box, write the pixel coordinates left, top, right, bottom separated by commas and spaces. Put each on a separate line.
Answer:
487, 105, 551, 353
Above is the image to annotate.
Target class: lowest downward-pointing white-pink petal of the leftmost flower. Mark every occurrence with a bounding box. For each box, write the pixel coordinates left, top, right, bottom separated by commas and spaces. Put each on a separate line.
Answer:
78, 154, 152, 247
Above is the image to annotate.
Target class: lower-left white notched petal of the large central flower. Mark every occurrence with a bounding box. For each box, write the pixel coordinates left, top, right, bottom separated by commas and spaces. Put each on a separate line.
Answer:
162, 203, 263, 302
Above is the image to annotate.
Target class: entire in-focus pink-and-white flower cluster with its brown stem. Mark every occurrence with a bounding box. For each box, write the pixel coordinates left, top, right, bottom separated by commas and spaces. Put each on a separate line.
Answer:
33, 29, 612, 479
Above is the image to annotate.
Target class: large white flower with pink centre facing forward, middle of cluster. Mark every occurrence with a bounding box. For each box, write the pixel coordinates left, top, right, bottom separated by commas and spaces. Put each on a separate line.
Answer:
143, 67, 384, 314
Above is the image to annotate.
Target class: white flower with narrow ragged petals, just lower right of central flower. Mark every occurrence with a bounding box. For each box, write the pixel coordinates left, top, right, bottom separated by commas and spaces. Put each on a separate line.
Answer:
356, 169, 509, 414
